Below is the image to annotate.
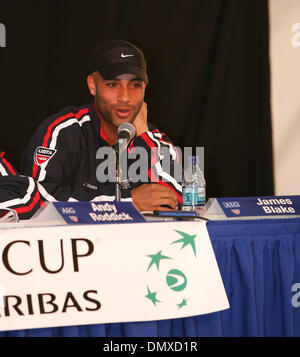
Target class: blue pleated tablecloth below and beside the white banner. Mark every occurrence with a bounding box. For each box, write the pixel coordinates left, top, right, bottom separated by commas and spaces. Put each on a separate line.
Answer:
0, 218, 300, 337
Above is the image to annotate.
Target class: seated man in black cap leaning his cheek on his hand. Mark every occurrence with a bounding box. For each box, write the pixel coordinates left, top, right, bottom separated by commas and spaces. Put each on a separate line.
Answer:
21, 40, 182, 211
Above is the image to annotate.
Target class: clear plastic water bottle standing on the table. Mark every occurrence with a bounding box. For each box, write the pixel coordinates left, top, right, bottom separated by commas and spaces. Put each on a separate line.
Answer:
182, 156, 206, 211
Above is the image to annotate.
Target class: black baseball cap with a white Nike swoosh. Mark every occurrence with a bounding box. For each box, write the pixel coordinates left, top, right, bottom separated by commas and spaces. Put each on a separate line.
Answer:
88, 40, 148, 83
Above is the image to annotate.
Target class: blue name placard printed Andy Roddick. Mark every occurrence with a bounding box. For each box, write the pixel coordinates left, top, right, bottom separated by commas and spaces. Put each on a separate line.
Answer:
35, 201, 146, 224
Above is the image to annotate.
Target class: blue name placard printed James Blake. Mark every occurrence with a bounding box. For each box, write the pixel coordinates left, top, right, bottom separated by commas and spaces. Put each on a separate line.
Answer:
207, 196, 300, 217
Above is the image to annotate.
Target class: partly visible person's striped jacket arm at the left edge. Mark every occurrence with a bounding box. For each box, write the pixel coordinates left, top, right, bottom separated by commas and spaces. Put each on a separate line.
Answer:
0, 149, 43, 219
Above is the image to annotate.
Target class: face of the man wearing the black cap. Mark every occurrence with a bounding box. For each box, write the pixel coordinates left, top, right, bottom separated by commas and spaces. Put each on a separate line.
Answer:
88, 72, 146, 130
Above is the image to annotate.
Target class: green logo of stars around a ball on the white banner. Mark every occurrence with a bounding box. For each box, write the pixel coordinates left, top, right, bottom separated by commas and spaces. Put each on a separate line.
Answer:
145, 230, 198, 311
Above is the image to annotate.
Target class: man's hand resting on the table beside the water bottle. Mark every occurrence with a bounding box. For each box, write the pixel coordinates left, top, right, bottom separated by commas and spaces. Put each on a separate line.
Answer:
131, 183, 178, 211
